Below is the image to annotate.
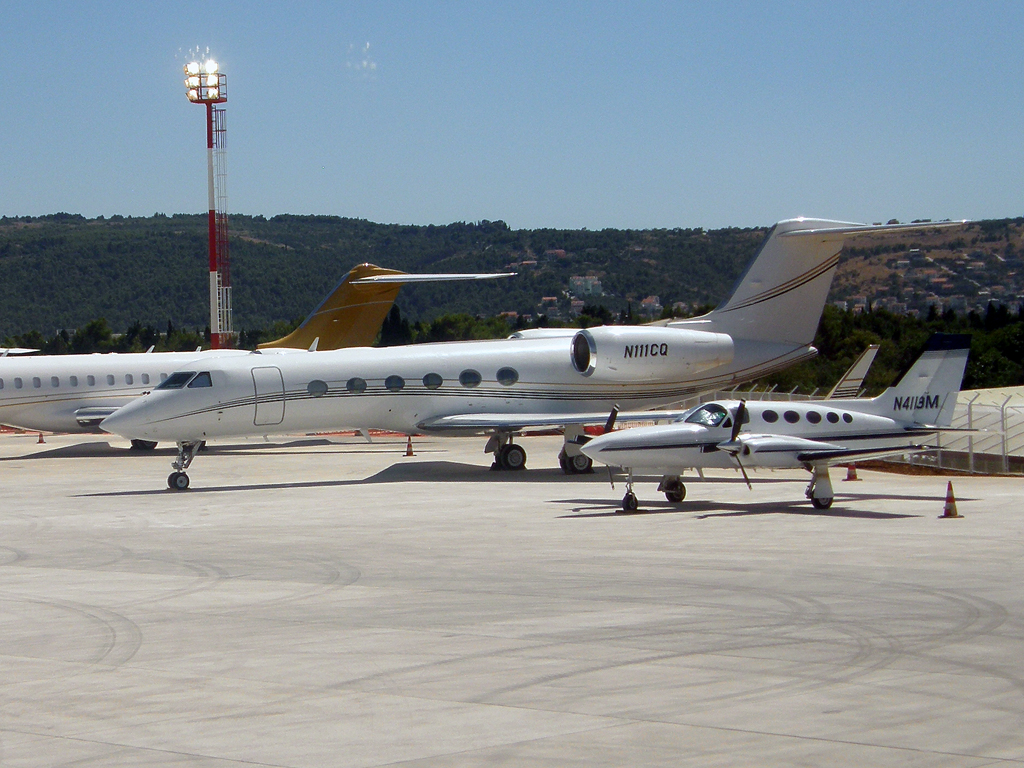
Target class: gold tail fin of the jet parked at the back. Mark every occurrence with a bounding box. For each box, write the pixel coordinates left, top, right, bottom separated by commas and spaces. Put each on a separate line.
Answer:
259, 264, 404, 351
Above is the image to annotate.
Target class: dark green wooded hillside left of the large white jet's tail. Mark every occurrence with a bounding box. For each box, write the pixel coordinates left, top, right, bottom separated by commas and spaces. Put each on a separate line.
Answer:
0, 214, 764, 338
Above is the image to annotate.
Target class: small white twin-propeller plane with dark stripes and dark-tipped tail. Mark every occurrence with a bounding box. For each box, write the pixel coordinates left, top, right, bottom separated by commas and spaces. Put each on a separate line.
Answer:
582, 334, 971, 512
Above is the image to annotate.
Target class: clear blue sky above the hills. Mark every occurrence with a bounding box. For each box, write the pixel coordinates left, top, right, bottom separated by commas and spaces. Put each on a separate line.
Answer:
0, 1, 1024, 229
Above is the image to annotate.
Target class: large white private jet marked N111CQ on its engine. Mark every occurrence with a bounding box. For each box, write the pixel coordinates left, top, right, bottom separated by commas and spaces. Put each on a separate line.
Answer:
100, 218, 963, 489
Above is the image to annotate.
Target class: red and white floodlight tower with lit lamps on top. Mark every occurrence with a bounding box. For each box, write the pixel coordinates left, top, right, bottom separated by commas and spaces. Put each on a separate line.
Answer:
185, 58, 231, 349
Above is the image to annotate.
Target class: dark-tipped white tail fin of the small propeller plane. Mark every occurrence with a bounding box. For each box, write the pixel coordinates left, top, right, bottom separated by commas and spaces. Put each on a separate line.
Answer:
865, 334, 971, 427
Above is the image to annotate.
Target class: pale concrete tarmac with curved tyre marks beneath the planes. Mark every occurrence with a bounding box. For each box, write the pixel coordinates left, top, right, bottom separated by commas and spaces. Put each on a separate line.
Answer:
0, 434, 1024, 768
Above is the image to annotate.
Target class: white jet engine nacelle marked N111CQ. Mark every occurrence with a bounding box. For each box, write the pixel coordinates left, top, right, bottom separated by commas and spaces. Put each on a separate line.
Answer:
571, 326, 733, 382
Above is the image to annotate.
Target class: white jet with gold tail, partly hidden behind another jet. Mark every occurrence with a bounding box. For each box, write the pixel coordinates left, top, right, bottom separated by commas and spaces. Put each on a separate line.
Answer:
0, 264, 512, 442
